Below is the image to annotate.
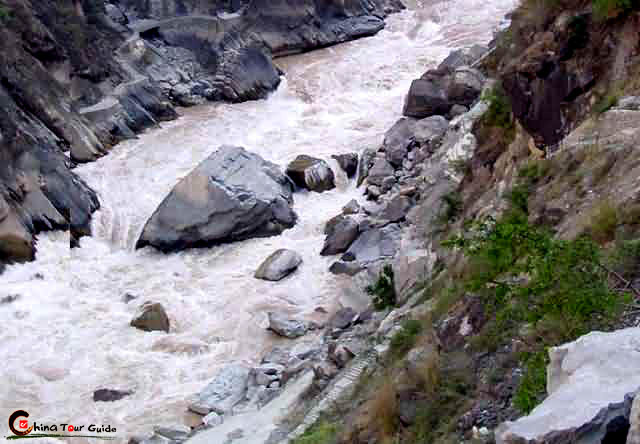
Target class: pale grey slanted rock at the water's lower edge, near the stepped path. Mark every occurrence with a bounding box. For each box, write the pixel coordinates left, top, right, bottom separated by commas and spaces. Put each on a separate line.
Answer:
189, 364, 249, 415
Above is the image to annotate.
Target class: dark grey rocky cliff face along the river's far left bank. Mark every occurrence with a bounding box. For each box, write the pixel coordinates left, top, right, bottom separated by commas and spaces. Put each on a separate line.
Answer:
0, 0, 401, 262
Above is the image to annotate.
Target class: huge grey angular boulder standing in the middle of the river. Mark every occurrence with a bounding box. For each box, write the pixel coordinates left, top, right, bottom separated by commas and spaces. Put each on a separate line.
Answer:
136, 146, 296, 252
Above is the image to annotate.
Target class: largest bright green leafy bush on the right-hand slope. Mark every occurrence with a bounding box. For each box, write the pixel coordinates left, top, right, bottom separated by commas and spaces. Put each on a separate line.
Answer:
445, 181, 628, 413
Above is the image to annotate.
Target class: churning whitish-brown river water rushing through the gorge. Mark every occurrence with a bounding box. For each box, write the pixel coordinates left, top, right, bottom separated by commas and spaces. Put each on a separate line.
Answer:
0, 0, 514, 444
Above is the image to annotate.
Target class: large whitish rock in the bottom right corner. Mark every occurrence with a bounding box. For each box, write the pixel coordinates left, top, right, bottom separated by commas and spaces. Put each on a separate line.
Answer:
495, 327, 640, 444
